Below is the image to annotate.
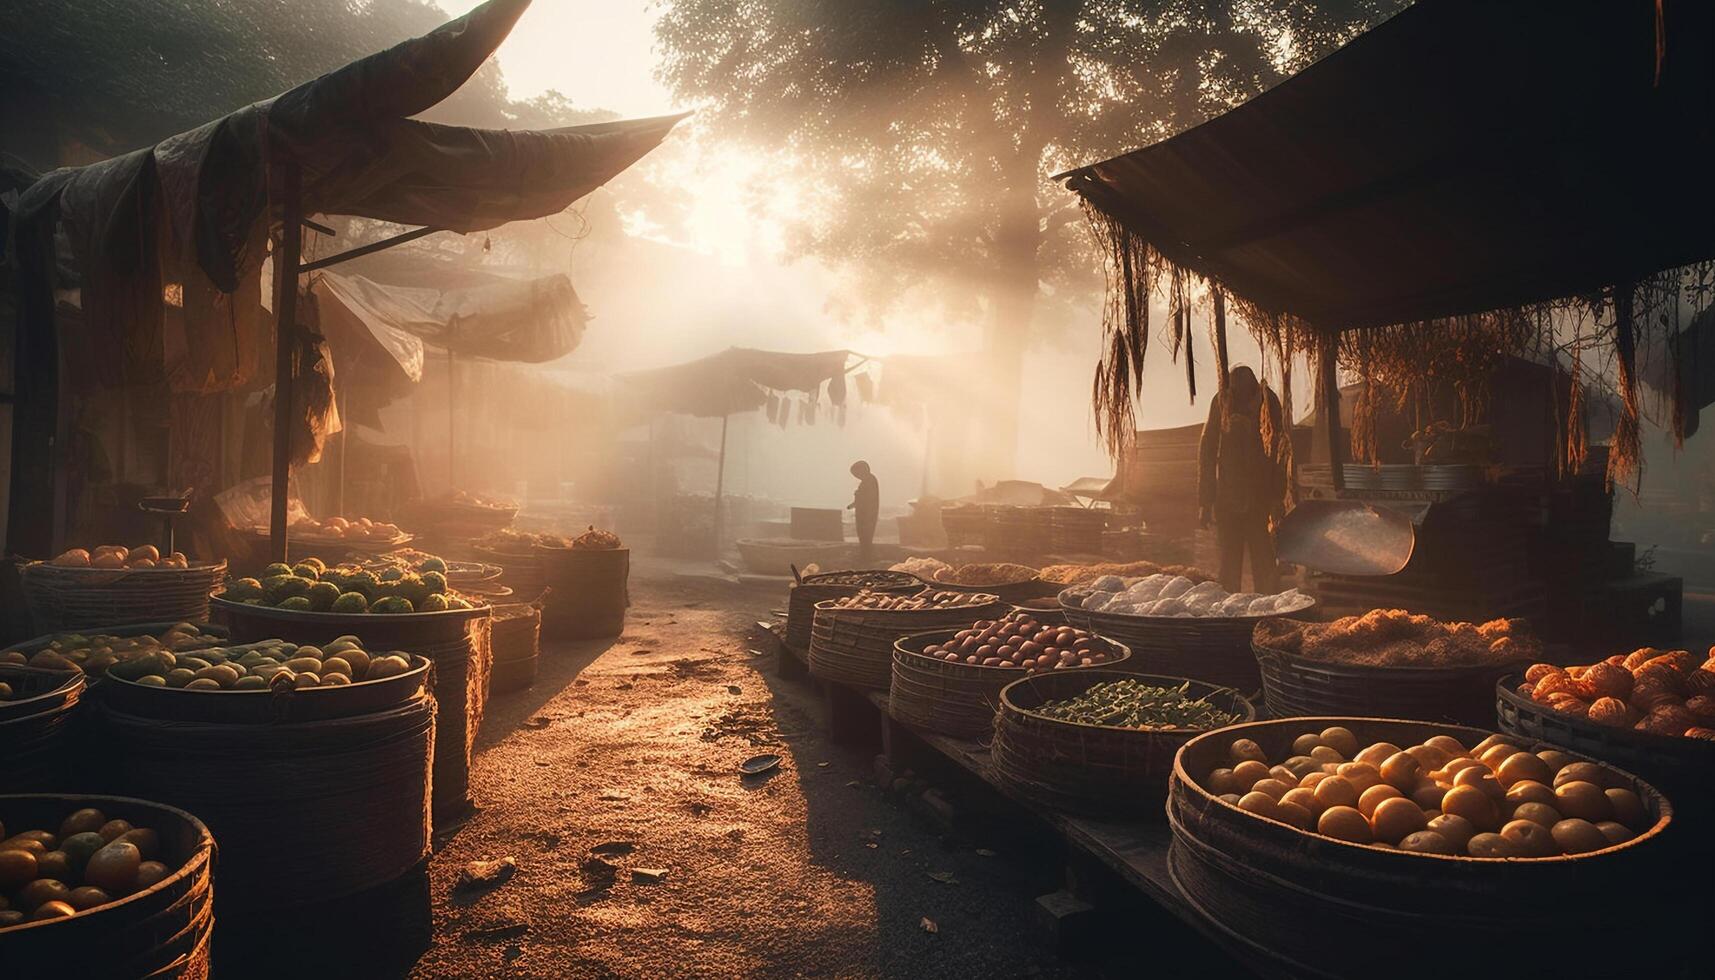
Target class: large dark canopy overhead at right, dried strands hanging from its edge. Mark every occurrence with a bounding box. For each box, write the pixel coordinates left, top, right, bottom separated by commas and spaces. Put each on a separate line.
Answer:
1065, 0, 1715, 330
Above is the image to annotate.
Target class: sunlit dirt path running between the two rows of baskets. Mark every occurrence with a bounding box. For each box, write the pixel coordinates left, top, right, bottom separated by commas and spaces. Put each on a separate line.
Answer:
412, 568, 1079, 978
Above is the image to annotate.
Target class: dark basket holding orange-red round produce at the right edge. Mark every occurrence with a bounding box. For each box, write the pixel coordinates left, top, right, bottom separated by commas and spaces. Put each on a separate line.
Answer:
1492, 675, 1715, 830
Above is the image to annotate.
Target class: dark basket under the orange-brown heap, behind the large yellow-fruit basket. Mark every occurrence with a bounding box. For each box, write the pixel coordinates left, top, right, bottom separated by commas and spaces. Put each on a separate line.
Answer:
1252, 620, 1521, 728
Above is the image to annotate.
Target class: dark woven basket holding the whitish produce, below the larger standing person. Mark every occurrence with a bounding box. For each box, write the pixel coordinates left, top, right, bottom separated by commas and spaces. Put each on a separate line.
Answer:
1060, 599, 1315, 693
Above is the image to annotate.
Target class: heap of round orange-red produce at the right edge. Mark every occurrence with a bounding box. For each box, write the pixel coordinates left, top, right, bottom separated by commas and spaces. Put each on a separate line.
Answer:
1518, 647, 1715, 740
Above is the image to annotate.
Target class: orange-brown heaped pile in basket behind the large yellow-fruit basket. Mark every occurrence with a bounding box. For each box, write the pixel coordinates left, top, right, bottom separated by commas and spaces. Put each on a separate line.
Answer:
1255, 609, 1542, 668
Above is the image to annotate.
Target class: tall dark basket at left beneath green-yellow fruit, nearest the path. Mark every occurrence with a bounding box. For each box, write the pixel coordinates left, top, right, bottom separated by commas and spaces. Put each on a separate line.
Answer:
101, 686, 436, 918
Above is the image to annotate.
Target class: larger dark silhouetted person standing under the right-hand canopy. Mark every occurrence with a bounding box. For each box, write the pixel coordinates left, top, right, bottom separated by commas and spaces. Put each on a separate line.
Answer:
1197, 367, 1286, 594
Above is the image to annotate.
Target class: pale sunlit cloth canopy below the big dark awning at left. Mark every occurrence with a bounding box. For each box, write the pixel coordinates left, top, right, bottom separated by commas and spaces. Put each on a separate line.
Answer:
316, 273, 588, 381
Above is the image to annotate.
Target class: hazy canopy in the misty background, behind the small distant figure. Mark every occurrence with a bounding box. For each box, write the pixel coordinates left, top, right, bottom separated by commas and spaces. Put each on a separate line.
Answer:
619, 347, 851, 419
